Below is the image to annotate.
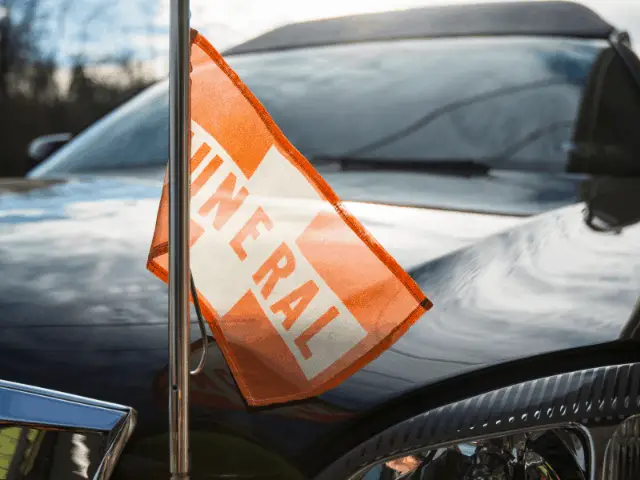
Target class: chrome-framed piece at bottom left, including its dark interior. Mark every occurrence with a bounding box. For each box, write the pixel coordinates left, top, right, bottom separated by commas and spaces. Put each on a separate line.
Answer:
0, 380, 135, 479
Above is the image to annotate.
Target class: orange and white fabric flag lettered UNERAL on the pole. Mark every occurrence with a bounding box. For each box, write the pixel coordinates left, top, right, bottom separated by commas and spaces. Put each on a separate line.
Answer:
147, 31, 431, 405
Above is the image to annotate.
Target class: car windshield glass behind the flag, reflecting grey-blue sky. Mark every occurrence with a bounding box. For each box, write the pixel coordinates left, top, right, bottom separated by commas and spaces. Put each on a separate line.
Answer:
31, 37, 606, 176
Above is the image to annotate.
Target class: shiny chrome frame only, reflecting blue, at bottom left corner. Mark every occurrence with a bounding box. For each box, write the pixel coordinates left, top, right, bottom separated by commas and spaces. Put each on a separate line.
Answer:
0, 380, 136, 480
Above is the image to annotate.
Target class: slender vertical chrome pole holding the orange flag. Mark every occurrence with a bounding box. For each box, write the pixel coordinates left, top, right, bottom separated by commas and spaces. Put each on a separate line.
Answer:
169, 0, 191, 480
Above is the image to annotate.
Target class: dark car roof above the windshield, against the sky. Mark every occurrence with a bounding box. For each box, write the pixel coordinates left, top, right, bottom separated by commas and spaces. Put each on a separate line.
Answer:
224, 1, 614, 55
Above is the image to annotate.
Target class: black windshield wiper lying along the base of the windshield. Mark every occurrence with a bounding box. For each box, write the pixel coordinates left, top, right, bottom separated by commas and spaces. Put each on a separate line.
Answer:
312, 156, 491, 176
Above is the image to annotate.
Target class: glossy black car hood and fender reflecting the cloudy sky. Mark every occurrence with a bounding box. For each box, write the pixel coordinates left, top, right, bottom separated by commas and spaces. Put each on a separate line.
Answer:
0, 174, 640, 478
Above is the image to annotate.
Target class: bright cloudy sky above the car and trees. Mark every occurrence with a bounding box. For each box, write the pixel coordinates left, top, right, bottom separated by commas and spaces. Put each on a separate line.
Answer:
16, 0, 640, 76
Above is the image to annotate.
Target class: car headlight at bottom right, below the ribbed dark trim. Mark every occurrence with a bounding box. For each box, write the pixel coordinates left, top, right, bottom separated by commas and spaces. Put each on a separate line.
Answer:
355, 415, 640, 480
